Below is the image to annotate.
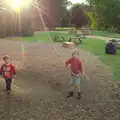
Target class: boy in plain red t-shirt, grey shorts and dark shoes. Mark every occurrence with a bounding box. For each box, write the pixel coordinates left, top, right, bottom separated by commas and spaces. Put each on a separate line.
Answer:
65, 51, 89, 99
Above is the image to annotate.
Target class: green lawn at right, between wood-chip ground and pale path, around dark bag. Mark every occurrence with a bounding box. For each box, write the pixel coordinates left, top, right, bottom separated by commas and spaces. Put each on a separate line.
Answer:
80, 39, 120, 80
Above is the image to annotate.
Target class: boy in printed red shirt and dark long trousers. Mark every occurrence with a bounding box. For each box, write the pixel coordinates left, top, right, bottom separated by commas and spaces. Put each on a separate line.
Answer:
0, 55, 16, 94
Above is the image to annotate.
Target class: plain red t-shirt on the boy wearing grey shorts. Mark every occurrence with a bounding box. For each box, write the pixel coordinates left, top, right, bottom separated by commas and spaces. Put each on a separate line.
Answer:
65, 58, 83, 74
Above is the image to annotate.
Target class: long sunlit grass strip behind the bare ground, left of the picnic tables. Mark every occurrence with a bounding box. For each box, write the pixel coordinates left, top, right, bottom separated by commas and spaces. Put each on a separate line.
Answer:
7, 32, 73, 42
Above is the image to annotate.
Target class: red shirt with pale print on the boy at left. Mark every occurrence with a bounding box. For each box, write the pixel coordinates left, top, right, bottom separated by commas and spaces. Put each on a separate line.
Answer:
0, 64, 16, 79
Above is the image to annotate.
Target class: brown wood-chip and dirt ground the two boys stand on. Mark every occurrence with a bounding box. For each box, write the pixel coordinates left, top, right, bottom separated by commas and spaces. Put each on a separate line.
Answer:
0, 40, 120, 120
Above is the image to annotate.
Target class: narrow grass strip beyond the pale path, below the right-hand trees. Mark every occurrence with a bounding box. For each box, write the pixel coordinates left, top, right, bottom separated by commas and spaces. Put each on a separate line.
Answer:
92, 31, 120, 38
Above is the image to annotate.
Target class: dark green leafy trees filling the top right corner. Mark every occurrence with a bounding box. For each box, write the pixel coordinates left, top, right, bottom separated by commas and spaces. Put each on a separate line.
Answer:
88, 0, 120, 32
